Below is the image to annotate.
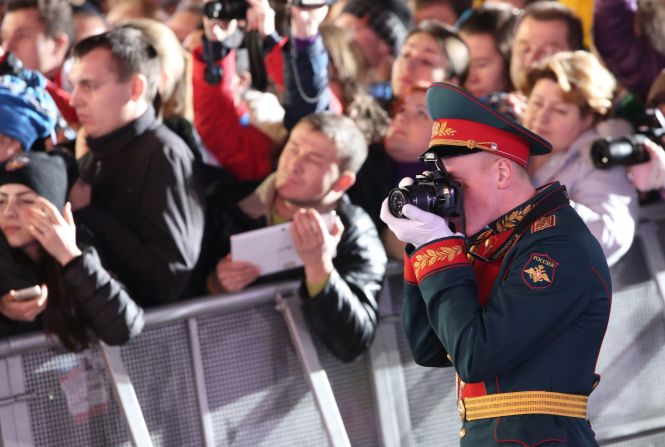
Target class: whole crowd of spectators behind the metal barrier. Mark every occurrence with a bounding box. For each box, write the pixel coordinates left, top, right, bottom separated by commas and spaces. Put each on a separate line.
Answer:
0, 0, 665, 361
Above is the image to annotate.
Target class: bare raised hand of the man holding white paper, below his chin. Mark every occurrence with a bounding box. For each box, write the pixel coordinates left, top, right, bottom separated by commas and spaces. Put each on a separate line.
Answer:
291, 208, 344, 283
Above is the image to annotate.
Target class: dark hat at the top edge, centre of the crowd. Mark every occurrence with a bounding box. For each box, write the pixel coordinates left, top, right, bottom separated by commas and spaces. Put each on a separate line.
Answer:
342, 0, 413, 56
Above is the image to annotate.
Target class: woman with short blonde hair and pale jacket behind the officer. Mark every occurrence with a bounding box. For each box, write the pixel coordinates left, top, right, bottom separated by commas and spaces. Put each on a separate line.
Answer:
524, 51, 637, 265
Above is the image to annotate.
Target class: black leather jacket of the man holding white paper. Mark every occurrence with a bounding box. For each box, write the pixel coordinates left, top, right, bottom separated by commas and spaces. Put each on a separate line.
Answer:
195, 178, 387, 361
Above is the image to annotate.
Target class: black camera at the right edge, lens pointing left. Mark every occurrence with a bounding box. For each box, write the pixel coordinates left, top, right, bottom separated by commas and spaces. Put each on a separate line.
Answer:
591, 108, 665, 169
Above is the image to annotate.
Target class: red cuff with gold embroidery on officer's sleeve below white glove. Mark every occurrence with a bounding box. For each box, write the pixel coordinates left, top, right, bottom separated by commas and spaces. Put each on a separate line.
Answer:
410, 237, 469, 282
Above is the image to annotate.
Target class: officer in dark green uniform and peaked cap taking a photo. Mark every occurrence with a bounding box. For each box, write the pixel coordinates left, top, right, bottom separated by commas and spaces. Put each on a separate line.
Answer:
381, 83, 612, 447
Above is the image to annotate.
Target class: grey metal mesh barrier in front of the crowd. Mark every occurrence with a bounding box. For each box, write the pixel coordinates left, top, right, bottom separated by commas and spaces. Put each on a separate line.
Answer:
0, 207, 665, 446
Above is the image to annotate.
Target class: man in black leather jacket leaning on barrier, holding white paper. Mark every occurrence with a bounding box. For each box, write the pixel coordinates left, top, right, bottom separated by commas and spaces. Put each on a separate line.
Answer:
204, 114, 387, 361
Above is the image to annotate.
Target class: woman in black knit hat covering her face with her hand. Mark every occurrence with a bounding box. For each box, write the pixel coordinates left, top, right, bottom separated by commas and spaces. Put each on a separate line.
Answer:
0, 152, 144, 351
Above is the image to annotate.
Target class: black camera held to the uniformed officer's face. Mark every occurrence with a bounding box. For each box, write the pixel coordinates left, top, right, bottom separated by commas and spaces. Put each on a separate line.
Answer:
388, 152, 463, 218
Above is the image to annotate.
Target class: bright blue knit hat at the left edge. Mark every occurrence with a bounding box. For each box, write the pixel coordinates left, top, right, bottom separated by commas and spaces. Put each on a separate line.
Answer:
0, 70, 58, 151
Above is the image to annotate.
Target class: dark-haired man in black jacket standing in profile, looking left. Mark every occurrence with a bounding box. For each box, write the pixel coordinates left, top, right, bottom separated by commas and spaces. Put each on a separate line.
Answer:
70, 28, 204, 305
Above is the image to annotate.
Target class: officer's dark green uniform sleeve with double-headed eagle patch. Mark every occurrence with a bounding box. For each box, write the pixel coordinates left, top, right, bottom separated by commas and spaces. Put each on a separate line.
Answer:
418, 235, 607, 382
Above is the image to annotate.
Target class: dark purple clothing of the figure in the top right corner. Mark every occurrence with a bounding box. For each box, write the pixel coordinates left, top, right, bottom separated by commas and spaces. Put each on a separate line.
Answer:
593, 0, 665, 101
